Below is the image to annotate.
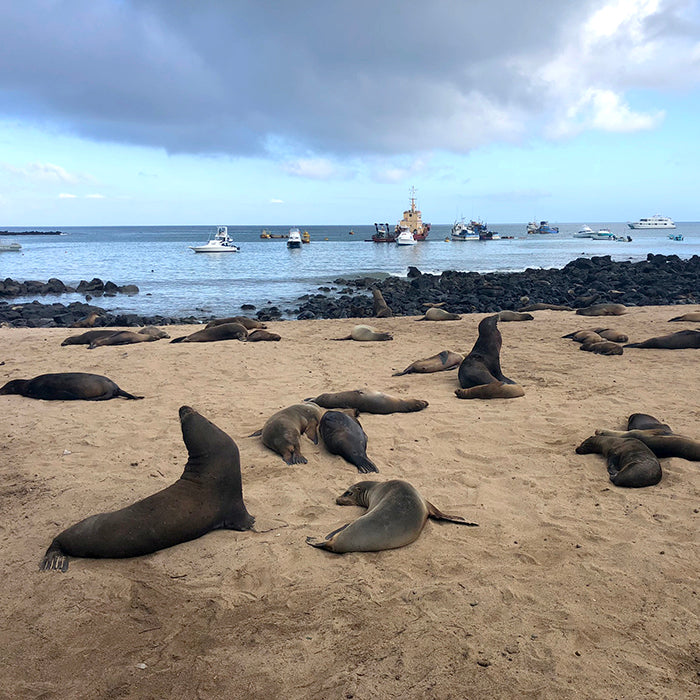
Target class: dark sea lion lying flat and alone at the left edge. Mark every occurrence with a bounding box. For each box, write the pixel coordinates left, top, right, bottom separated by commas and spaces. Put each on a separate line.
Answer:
0, 372, 143, 401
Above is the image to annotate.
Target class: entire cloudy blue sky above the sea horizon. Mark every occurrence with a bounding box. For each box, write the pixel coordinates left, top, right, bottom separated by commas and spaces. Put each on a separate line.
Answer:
0, 0, 700, 224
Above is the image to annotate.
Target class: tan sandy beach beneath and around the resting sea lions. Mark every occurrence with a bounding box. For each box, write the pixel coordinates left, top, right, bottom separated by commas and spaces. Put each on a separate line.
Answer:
0, 307, 700, 700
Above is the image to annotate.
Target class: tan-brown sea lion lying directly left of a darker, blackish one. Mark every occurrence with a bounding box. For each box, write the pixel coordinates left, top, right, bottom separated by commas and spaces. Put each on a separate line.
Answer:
248, 402, 323, 464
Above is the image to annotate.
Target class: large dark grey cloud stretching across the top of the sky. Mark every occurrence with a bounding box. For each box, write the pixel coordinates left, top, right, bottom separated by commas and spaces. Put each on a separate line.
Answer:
0, 0, 692, 155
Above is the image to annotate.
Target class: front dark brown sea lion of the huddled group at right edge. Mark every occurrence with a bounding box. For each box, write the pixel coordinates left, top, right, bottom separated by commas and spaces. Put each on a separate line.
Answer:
576, 435, 661, 488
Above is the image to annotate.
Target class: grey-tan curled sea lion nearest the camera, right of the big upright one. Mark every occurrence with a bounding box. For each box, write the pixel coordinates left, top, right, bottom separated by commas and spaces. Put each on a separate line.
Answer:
306, 479, 477, 554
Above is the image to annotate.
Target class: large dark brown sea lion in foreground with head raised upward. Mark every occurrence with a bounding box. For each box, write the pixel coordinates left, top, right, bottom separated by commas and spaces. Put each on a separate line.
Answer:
40, 406, 255, 571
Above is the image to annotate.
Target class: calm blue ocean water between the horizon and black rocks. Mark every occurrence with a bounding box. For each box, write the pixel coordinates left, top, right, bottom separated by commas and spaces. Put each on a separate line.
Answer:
0, 221, 700, 317
